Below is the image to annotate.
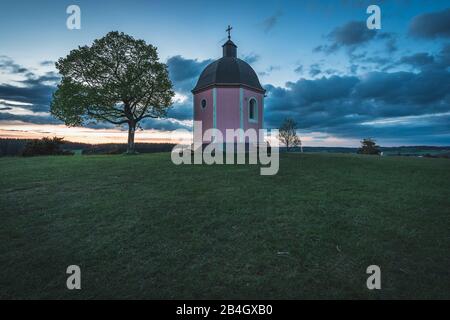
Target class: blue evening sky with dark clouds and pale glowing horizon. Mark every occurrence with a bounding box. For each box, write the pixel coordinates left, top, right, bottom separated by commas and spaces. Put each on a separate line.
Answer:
0, 0, 450, 147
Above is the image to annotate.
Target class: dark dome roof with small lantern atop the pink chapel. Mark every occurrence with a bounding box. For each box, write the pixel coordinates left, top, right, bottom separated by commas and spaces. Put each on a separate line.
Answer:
192, 40, 265, 93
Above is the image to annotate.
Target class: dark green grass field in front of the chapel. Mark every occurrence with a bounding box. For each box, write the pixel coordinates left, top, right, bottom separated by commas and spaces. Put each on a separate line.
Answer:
0, 154, 450, 299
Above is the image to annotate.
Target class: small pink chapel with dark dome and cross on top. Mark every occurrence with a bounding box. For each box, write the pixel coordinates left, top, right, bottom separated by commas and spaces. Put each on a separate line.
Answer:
192, 27, 265, 143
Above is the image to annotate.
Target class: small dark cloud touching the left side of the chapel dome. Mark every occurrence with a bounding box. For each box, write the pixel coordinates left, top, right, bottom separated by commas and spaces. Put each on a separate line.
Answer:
167, 55, 212, 93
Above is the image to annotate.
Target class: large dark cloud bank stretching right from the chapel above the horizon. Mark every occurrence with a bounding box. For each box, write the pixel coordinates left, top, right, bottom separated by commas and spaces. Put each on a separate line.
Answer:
265, 69, 450, 143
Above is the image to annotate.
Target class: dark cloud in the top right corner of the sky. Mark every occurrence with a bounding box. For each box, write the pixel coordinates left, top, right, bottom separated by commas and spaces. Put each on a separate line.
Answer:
409, 8, 450, 39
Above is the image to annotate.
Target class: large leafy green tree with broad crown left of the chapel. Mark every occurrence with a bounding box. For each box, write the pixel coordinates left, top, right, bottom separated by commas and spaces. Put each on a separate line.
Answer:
51, 32, 174, 153
